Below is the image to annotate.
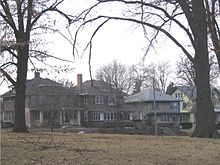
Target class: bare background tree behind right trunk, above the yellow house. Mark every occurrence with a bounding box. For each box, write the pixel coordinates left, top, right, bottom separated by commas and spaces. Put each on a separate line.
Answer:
176, 55, 219, 86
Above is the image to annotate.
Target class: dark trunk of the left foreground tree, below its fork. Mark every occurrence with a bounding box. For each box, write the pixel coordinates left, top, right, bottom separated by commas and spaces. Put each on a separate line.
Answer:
13, 42, 29, 132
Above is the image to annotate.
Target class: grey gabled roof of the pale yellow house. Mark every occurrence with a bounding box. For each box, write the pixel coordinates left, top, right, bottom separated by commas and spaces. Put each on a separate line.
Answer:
168, 85, 196, 99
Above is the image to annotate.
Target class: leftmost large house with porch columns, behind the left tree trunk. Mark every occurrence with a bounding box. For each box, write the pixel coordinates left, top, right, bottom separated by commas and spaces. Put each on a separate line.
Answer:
1, 73, 83, 127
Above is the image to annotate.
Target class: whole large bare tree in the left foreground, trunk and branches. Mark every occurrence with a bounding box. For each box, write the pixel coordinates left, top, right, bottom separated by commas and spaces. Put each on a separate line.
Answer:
0, 0, 70, 132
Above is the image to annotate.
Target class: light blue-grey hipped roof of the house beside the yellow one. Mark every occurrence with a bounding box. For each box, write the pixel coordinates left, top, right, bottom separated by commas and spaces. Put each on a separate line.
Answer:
125, 88, 180, 103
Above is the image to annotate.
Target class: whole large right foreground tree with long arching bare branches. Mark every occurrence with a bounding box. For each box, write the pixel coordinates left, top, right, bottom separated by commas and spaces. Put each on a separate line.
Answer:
74, 0, 217, 137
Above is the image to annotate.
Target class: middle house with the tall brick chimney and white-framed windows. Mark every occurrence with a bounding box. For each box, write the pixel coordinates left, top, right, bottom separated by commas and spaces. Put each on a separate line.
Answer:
77, 75, 124, 127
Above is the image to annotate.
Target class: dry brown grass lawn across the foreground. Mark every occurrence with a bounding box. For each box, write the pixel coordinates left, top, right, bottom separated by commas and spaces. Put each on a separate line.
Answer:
1, 130, 220, 165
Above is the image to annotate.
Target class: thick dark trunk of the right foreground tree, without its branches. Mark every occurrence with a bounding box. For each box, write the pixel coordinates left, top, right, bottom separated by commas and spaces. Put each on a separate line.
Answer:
192, 0, 217, 138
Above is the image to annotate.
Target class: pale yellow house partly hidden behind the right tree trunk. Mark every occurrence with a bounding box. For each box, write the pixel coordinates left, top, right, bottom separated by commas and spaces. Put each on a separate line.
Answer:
167, 85, 220, 128
